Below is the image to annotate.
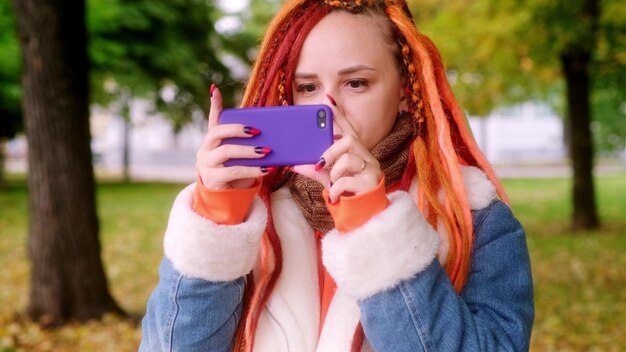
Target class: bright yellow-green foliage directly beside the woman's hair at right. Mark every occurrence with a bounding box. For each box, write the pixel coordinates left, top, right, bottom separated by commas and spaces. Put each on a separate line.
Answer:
411, 0, 558, 116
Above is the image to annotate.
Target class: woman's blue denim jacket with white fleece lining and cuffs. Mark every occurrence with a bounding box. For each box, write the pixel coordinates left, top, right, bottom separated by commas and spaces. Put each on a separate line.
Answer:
140, 168, 534, 352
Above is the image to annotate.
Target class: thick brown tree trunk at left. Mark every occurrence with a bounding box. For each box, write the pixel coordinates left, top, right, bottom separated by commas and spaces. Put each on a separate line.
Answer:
13, 0, 122, 325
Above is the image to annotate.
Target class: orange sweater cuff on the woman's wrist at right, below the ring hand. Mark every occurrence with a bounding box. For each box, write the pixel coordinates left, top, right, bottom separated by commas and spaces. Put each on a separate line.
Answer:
322, 177, 389, 234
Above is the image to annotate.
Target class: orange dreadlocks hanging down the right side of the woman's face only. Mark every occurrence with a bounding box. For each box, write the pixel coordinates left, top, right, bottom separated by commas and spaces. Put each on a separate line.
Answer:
386, 3, 506, 292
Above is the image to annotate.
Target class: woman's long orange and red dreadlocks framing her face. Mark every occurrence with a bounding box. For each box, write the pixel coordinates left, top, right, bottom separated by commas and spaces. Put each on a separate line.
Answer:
235, 0, 507, 351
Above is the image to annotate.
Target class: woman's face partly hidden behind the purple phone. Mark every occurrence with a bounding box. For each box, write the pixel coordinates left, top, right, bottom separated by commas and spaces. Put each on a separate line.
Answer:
292, 11, 405, 150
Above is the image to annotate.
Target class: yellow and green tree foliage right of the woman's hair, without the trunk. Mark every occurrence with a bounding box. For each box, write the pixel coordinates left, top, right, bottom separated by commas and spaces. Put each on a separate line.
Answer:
411, 0, 626, 150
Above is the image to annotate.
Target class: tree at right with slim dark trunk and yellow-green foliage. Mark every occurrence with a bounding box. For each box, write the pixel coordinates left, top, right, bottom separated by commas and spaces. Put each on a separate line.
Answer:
413, 0, 626, 229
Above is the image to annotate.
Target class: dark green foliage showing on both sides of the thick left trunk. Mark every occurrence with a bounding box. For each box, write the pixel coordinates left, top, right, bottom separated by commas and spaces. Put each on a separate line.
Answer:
0, 0, 239, 184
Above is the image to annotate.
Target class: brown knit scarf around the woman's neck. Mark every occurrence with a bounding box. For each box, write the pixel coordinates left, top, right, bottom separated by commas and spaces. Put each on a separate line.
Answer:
288, 113, 415, 233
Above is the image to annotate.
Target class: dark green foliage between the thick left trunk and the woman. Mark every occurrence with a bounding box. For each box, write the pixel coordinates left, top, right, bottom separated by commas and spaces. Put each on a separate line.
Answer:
88, 0, 232, 130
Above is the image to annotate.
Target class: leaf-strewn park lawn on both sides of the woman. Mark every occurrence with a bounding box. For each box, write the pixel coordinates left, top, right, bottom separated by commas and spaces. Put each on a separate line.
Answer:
0, 174, 626, 352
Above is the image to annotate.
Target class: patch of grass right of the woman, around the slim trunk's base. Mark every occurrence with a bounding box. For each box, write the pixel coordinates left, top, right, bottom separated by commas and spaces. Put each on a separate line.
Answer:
505, 174, 626, 351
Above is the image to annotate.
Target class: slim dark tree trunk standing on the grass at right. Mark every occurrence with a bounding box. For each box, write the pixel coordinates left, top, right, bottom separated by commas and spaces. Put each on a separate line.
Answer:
561, 50, 600, 230
